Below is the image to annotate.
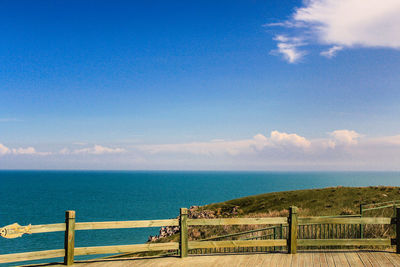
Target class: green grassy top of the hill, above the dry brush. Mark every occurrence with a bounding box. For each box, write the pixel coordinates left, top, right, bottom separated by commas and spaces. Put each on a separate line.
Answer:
203, 186, 400, 216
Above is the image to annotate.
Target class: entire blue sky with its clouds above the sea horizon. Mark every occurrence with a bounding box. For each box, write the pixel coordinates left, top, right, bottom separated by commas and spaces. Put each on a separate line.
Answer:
0, 0, 400, 170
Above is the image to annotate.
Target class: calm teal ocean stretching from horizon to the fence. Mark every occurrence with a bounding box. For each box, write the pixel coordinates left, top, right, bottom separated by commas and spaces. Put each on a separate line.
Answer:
0, 171, 400, 262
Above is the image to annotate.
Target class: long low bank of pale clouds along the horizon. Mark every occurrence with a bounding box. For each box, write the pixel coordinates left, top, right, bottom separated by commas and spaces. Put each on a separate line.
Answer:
0, 129, 400, 170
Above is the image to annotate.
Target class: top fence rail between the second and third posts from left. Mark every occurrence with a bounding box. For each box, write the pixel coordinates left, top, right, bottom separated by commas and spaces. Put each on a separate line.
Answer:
188, 217, 287, 226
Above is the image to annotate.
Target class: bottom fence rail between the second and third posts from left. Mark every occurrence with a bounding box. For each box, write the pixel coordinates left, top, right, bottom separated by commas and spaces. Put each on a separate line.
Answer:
189, 239, 286, 249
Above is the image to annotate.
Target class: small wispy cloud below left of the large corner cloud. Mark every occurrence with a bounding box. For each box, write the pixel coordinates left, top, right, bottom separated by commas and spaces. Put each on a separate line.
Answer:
272, 35, 306, 63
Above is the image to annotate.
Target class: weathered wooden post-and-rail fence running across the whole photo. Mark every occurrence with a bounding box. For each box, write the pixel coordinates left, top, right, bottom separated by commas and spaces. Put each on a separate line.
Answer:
0, 207, 400, 265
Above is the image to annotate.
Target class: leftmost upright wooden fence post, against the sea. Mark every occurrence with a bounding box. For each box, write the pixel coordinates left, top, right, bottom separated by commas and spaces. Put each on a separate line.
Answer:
64, 210, 75, 265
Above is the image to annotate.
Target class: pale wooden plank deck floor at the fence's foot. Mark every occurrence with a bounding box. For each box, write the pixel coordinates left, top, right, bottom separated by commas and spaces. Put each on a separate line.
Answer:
41, 251, 400, 267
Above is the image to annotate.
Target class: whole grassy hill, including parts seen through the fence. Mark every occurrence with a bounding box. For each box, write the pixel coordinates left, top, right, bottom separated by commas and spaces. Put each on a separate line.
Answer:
113, 186, 400, 256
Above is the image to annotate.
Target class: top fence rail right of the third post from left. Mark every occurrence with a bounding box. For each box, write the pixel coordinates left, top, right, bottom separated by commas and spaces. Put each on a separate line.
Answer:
298, 217, 392, 224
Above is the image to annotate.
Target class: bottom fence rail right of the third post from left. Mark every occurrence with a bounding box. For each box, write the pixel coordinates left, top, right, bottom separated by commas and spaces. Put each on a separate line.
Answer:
297, 238, 391, 246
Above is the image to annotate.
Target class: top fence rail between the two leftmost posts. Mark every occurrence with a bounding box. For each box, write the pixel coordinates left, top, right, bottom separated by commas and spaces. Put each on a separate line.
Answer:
75, 219, 179, 230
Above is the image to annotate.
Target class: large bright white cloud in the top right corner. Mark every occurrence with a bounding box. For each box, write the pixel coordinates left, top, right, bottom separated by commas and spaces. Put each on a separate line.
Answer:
266, 0, 400, 62
